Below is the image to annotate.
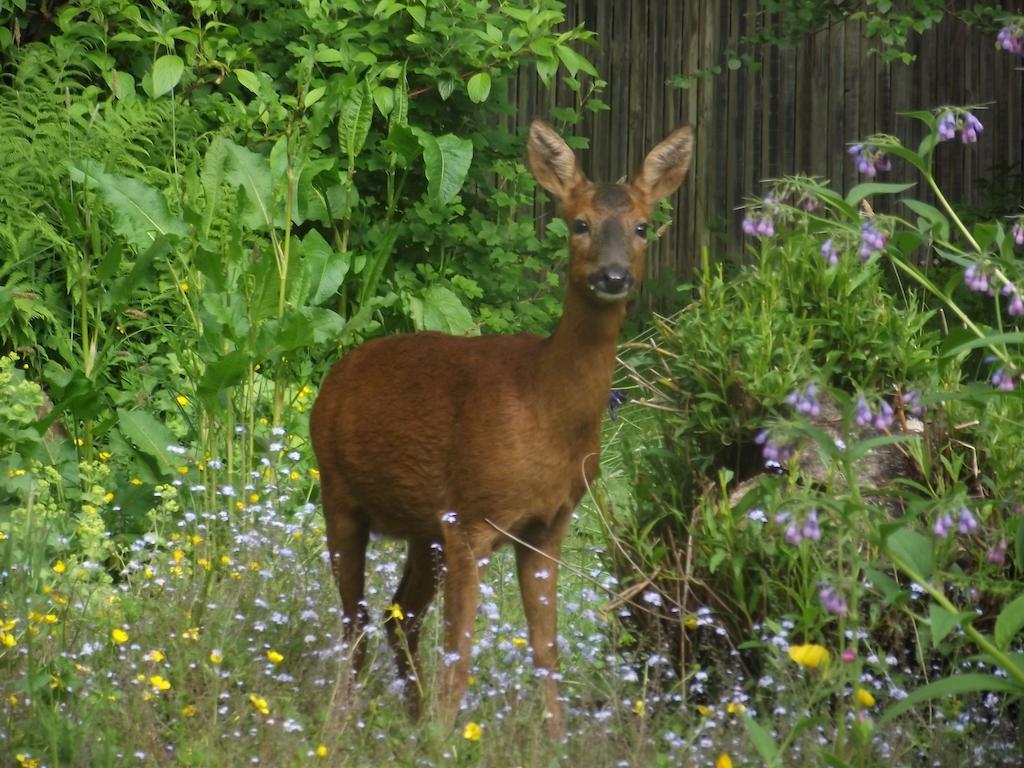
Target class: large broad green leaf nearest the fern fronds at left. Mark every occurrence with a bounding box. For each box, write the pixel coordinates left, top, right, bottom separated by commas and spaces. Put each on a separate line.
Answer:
68, 160, 188, 251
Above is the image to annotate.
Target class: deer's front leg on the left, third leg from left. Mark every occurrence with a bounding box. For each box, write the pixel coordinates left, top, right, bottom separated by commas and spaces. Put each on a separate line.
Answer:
440, 524, 480, 727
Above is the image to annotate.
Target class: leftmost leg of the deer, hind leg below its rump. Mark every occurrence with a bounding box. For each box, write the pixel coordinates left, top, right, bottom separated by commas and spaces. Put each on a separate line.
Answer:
321, 472, 370, 672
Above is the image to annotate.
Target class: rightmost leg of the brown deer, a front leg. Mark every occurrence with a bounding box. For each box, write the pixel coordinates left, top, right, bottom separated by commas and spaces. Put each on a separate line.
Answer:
515, 515, 568, 738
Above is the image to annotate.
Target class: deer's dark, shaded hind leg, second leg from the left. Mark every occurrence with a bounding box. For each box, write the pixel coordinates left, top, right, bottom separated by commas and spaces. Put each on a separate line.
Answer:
385, 539, 440, 717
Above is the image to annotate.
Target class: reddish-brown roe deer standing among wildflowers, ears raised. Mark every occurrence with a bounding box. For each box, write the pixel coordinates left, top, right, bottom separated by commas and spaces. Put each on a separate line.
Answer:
310, 121, 692, 734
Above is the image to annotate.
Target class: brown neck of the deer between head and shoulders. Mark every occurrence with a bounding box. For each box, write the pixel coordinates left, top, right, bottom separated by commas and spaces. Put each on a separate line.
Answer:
538, 285, 626, 423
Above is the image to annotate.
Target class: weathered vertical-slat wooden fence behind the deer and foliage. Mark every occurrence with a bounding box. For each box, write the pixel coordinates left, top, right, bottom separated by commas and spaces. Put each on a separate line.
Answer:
512, 0, 1024, 303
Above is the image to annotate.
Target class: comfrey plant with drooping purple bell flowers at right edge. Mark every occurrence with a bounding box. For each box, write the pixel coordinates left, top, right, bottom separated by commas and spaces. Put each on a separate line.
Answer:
744, 102, 1024, 760
